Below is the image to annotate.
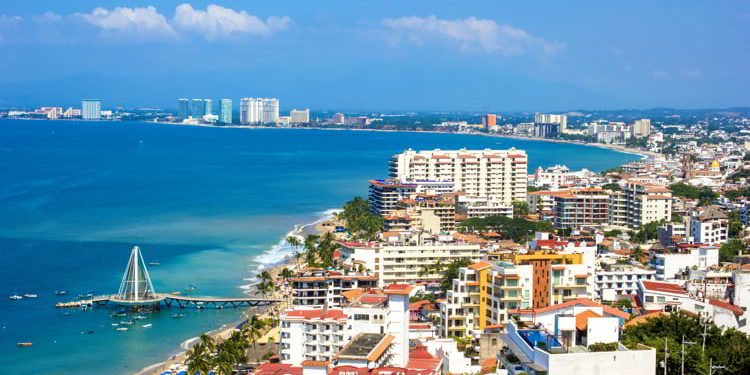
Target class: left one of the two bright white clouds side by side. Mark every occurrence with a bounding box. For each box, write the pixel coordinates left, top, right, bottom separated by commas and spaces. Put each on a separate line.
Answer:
78, 6, 177, 36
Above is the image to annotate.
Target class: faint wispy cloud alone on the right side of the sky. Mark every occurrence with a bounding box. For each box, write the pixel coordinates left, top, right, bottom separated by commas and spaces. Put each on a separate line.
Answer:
382, 16, 563, 56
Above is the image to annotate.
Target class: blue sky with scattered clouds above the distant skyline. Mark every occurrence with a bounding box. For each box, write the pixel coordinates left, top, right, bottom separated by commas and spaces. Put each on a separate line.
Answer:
0, 0, 750, 112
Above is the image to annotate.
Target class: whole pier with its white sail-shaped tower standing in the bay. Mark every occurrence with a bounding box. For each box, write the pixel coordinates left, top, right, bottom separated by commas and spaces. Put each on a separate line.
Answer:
55, 246, 284, 310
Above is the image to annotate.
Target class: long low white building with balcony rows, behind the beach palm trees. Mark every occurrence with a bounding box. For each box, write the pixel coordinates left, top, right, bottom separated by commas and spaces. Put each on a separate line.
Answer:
339, 241, 482, 286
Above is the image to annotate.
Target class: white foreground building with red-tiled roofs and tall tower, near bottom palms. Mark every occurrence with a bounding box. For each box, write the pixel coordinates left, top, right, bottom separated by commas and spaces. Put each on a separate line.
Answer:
279, 284, 413, 368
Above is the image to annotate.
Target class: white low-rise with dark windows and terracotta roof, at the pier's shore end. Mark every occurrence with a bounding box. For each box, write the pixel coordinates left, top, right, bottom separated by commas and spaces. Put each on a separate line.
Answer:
288, 268, 378, 307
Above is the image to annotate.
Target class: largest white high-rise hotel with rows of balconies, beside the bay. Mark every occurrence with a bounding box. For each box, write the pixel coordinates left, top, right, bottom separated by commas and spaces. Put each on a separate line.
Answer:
388, 148, 528, 205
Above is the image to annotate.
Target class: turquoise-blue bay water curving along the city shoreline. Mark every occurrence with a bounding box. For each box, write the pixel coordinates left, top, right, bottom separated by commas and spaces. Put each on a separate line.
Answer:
0, 120, 638, 374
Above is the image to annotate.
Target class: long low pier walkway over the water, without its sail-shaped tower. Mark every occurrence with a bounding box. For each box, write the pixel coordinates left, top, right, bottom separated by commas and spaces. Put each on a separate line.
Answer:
55, 293, 285, 309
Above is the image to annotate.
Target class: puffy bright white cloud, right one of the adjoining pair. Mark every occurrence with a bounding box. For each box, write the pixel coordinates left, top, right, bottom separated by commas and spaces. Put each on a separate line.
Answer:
173, 4, 290, 40
